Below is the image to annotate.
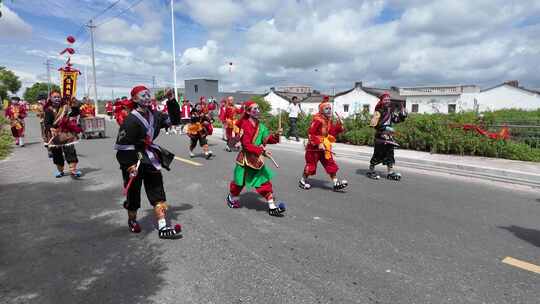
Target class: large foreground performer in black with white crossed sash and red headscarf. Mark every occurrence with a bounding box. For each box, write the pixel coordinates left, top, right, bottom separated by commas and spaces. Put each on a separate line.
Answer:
115, 86, 180, 238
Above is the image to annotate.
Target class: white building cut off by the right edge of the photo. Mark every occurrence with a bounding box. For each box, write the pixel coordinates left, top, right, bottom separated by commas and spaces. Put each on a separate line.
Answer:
476, 81, 540, 112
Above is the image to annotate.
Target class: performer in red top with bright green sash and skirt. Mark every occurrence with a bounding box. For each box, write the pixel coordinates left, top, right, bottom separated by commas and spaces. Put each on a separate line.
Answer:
226, 101, 285, 217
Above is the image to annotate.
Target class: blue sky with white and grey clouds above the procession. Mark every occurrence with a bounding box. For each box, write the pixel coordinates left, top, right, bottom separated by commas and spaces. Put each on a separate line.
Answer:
0, 0, 540, 97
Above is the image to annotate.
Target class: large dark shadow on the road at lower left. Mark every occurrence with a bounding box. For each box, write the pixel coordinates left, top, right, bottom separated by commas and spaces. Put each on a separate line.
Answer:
0, 180, 193, 303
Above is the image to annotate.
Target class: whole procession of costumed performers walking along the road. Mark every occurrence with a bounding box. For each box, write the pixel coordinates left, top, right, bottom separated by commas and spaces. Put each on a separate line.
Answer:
5, 85, 407, 238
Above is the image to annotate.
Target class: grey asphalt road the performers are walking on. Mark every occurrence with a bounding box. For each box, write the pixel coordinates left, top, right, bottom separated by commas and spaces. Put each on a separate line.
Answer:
0, 114, 540, 304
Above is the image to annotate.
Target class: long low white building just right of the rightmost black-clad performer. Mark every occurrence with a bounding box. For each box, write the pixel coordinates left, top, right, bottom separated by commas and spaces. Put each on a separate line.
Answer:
399, 85, 480, 113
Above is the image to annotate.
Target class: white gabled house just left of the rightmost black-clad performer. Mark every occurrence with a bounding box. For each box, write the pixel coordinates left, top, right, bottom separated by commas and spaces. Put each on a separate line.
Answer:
334, 82, 405, 118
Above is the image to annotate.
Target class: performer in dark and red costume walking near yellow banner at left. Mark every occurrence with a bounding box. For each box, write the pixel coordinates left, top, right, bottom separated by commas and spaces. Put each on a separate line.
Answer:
43, 92, 82, 178
